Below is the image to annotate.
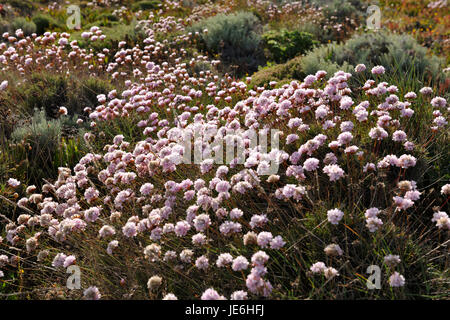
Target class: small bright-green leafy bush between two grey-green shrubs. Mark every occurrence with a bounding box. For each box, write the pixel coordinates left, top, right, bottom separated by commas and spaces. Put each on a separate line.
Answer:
262, 29, 317, 63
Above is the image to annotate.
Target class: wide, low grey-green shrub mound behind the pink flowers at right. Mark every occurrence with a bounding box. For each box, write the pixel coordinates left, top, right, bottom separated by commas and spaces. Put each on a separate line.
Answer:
251, 32, 443, 86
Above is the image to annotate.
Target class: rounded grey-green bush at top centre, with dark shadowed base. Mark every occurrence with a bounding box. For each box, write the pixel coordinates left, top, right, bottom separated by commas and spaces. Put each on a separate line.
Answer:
189, 11, 264, 75
